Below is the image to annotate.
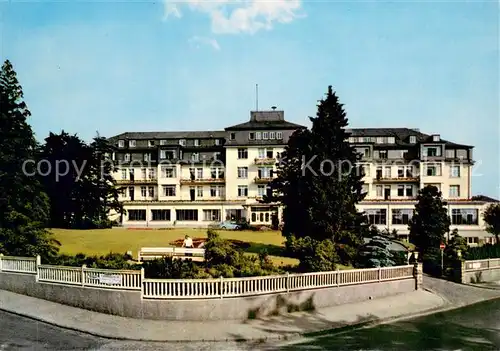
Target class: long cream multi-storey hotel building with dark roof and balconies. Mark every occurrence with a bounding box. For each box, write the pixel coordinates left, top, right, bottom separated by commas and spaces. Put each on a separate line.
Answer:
110, 110, 496, 245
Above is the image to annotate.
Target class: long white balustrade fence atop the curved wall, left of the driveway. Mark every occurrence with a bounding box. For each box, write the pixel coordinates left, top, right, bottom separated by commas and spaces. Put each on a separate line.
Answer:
0, 255, 415, 299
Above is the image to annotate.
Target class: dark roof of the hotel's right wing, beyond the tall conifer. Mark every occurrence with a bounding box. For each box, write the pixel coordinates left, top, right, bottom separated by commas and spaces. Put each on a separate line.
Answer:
347, 128, 473, 148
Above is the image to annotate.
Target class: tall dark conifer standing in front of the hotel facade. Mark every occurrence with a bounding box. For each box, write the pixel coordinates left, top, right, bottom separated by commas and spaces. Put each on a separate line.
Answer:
265, 86, 367, 259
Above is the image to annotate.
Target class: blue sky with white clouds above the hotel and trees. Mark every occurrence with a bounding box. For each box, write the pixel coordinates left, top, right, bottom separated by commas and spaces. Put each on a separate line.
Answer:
0, 0, 500, 197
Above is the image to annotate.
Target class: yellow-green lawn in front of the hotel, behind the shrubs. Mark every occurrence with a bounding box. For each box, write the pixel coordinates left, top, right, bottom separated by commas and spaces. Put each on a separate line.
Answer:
51, 228, 298, 265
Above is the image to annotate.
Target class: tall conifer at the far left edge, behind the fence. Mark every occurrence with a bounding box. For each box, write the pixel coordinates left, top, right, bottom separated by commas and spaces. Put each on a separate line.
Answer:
0, 60, 58, 257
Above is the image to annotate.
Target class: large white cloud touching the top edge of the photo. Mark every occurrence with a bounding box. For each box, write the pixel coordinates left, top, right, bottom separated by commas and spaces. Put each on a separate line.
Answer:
165, 0, 303, 34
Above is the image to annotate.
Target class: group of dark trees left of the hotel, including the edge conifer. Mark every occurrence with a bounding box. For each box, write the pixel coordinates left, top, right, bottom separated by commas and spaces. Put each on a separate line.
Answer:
0, 60, 123, 257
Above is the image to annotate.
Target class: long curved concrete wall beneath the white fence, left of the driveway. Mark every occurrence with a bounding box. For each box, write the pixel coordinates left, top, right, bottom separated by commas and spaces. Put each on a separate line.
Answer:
0, 272, 416, 321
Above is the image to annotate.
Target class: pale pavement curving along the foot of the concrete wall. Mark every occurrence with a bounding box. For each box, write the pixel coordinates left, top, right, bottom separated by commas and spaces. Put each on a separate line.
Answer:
0, 276, 500, 342
